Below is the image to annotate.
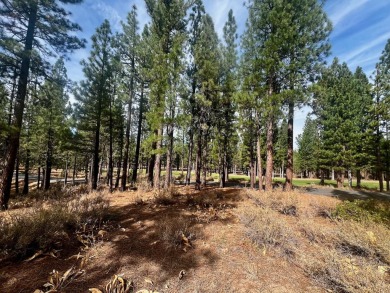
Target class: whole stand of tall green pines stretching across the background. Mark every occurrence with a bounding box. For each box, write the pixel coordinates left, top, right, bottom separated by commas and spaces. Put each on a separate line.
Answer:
0, 0, 390, 209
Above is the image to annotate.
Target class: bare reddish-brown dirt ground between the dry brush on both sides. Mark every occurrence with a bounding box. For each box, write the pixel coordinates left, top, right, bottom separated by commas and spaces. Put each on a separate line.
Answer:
0, 187, 384, 292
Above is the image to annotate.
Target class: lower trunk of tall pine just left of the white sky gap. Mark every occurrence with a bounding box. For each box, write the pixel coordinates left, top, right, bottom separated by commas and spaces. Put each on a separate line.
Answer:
284, 99, 295, 191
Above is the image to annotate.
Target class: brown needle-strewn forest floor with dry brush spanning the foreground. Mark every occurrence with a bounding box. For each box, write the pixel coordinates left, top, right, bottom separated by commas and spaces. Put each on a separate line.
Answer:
0, 187, 390, 292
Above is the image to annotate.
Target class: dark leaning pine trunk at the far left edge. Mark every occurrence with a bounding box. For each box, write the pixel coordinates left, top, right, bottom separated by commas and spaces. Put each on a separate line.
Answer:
0, 1, 38, 210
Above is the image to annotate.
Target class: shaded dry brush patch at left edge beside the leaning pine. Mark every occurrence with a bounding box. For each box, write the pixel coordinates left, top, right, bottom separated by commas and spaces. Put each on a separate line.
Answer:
0, 193, 109, 258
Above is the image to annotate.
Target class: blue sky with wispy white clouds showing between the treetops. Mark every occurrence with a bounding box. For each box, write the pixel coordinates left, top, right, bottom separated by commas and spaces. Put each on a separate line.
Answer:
63, 0, 390, 141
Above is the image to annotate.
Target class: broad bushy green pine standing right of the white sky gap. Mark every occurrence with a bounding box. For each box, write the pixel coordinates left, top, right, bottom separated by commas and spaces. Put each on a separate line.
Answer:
314, 58, 362, 187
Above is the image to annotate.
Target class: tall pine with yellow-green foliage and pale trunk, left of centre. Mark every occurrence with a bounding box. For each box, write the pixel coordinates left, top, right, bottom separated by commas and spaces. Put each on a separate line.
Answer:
146, 0, 191, 188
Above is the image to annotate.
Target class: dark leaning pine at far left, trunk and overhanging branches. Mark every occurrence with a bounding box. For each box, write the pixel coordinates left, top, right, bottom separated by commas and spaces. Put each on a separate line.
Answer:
0, 0, 84, 209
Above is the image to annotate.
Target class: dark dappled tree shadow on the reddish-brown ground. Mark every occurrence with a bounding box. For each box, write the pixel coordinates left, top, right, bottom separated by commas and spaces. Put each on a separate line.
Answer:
0, 187, 242, 292
